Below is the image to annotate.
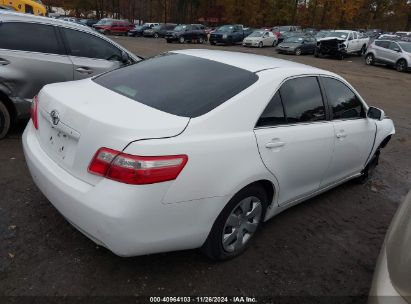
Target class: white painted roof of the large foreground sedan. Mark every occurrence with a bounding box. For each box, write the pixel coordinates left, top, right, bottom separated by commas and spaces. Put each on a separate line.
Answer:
172, 49, 321, 72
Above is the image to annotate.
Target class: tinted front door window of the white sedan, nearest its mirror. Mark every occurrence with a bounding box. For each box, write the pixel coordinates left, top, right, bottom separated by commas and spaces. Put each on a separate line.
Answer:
322, 77, 365, 119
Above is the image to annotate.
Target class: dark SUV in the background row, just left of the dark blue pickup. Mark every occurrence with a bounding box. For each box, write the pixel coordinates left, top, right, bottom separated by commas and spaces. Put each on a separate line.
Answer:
164, 24, 207, 43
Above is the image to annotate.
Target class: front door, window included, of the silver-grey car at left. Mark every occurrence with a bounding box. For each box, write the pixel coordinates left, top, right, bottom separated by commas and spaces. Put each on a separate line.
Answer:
61, 28, 122, 80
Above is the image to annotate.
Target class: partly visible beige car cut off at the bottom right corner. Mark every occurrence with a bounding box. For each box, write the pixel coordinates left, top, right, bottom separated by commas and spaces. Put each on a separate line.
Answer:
368, 192, 411, 304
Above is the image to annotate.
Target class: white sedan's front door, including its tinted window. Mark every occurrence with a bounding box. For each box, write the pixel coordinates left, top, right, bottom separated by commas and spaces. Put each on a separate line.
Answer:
321, 77, 376, 186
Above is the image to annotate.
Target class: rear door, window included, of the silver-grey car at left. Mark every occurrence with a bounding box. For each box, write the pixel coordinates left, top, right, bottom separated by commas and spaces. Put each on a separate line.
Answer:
0, 22, 73, 99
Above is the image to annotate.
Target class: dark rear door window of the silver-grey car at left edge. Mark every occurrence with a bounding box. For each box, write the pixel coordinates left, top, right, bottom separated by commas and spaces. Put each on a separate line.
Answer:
0, 22, 65, 54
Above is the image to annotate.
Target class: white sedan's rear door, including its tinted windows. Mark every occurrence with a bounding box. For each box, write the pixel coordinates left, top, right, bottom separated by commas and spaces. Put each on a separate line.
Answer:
254, 76, 334, 205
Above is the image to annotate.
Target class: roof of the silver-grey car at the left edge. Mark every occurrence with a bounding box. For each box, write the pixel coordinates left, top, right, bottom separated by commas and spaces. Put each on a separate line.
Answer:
0, 11, 94, 32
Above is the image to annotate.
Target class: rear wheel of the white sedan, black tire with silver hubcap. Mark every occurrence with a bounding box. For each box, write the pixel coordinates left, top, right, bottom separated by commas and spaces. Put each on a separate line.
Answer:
201, 184, 267, 260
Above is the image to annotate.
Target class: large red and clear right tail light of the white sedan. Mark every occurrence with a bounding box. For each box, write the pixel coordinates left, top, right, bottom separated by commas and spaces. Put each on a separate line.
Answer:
88, 148, 188, 185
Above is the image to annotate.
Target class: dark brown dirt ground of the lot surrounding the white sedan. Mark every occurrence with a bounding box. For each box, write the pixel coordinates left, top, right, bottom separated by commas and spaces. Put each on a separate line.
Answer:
0, 37, 411, 302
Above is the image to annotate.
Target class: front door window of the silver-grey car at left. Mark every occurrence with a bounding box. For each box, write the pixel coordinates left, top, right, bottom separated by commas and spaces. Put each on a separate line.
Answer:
63, 29, 121, 61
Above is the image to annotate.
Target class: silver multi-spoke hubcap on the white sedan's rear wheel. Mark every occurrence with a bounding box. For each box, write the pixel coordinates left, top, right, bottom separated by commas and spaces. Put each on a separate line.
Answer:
222, 196, 263, 252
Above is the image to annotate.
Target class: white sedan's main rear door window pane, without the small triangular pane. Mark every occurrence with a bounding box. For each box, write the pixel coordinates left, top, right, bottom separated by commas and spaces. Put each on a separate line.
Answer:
280, 77, 326, 123
